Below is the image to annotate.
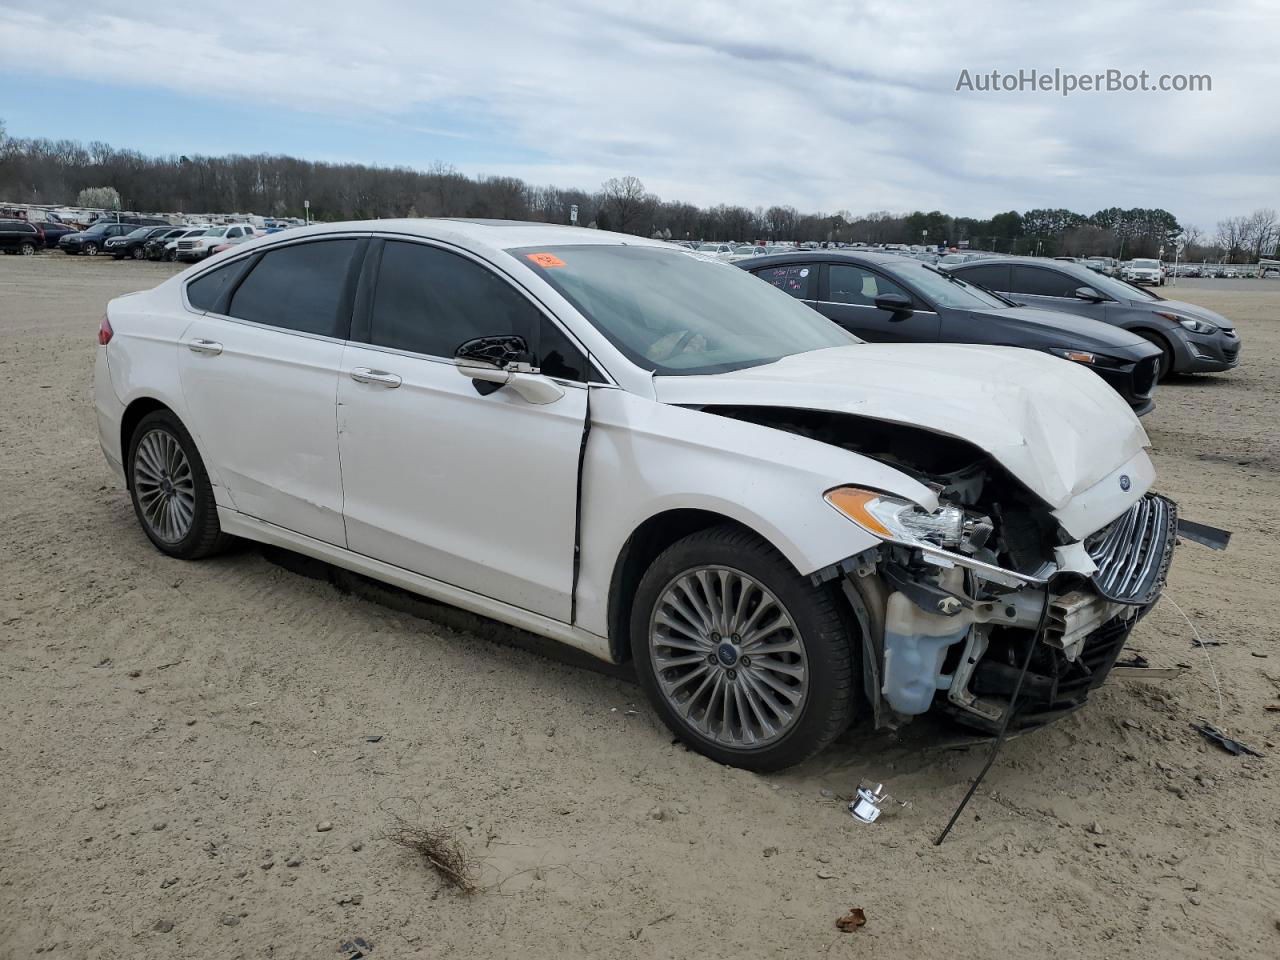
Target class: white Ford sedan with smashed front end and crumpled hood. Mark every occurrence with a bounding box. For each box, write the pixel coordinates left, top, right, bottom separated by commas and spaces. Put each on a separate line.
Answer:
96, 220, 1178, 771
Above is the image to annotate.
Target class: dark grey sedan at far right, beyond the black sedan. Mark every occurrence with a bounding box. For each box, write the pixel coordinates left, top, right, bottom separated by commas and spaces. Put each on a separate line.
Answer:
948, 257, 1240, 379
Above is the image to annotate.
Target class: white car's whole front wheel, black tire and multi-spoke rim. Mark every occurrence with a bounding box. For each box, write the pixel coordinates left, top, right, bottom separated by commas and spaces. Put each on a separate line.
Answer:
630, 526, 856, 773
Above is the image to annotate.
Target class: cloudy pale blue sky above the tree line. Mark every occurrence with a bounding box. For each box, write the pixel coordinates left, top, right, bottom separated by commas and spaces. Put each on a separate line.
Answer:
0, 0, 1280, 228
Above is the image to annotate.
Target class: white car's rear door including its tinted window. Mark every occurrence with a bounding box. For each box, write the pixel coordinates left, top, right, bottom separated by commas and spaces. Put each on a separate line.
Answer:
178, 237, 367, 545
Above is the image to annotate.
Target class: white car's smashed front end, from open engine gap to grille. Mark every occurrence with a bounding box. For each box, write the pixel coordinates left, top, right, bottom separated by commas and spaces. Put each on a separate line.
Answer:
717, 408, 1178, 732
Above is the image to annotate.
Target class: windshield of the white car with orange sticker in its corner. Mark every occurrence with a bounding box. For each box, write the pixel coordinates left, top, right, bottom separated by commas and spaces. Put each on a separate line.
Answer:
508, 243, 860, 375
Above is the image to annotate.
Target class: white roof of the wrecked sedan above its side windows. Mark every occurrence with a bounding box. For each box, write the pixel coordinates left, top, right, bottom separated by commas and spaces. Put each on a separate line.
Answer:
270, 218, 672, 250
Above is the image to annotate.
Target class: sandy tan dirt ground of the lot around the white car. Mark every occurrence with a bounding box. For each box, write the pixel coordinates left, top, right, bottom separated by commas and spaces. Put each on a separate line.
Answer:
0, 253, 1280, 960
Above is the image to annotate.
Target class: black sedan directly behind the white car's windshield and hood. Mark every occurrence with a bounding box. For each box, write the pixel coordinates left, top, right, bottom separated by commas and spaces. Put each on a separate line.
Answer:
736, 251, 1160, 416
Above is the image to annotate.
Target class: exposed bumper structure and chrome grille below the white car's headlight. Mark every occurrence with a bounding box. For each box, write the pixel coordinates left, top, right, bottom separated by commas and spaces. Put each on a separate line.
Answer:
815, 494, 1176, 732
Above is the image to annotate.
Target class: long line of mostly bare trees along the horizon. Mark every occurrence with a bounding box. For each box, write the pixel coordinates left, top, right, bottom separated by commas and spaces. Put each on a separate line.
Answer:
0, 124, 1280, 262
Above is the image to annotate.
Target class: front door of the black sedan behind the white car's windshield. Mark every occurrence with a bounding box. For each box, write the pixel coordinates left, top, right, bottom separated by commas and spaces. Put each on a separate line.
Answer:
815, 264, 941, 343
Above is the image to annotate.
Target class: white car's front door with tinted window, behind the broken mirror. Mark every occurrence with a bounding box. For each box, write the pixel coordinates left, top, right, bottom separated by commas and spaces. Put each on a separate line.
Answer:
338, 239, 588, 622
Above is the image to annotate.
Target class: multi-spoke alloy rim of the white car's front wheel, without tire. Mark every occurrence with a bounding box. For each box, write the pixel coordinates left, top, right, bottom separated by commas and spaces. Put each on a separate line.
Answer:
649, 566, 809, 749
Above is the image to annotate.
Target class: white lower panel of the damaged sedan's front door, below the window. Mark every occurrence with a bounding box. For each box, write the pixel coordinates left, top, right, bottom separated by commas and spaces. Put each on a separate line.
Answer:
338, 343, 586, 622
